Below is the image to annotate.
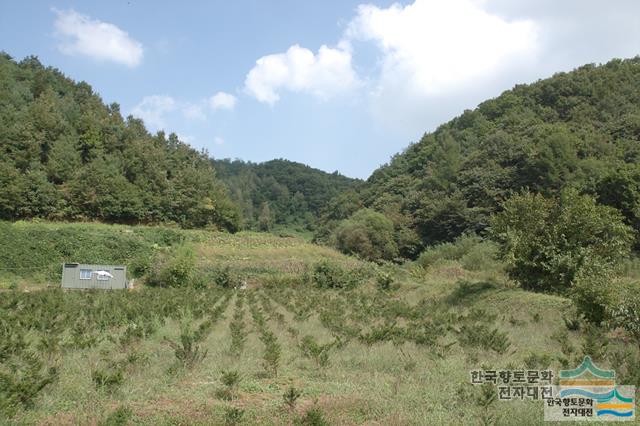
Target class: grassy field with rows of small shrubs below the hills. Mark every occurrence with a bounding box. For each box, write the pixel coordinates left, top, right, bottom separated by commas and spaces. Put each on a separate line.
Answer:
0, 223, 638, 425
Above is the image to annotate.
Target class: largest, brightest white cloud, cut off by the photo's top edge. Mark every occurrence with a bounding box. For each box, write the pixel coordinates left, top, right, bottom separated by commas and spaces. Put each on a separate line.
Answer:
345, 0, 537, 96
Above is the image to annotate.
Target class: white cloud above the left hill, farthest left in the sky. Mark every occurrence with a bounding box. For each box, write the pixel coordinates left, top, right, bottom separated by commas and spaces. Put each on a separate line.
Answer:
53, 9, 143, 67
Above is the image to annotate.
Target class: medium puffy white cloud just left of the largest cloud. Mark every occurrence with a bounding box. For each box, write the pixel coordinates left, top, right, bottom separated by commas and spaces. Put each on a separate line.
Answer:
245, 44, 359, 105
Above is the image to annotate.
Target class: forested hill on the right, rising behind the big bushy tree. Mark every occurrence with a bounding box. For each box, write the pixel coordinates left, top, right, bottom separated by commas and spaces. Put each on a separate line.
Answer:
363, 57, 640, 256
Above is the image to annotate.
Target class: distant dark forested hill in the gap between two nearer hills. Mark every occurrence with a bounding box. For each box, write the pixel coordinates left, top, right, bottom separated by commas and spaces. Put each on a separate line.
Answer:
212, 159, 362, 230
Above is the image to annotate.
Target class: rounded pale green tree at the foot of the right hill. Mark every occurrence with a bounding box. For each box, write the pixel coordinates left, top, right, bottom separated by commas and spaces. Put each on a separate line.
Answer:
334, 209, 398, 261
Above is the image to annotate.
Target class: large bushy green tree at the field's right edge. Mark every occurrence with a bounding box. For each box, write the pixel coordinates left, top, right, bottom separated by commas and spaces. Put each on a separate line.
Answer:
491, 190, 633, 293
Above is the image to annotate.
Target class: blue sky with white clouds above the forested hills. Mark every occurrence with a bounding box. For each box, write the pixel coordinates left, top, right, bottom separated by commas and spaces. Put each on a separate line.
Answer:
0, 0, 640, 178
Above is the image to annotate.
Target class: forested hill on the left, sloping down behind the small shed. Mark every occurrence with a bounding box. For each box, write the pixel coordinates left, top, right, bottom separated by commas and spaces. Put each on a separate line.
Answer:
0, 53, 239, 230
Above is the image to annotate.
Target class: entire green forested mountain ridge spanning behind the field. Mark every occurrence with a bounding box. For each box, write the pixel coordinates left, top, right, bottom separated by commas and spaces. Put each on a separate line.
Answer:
0, 54, 640, 258
